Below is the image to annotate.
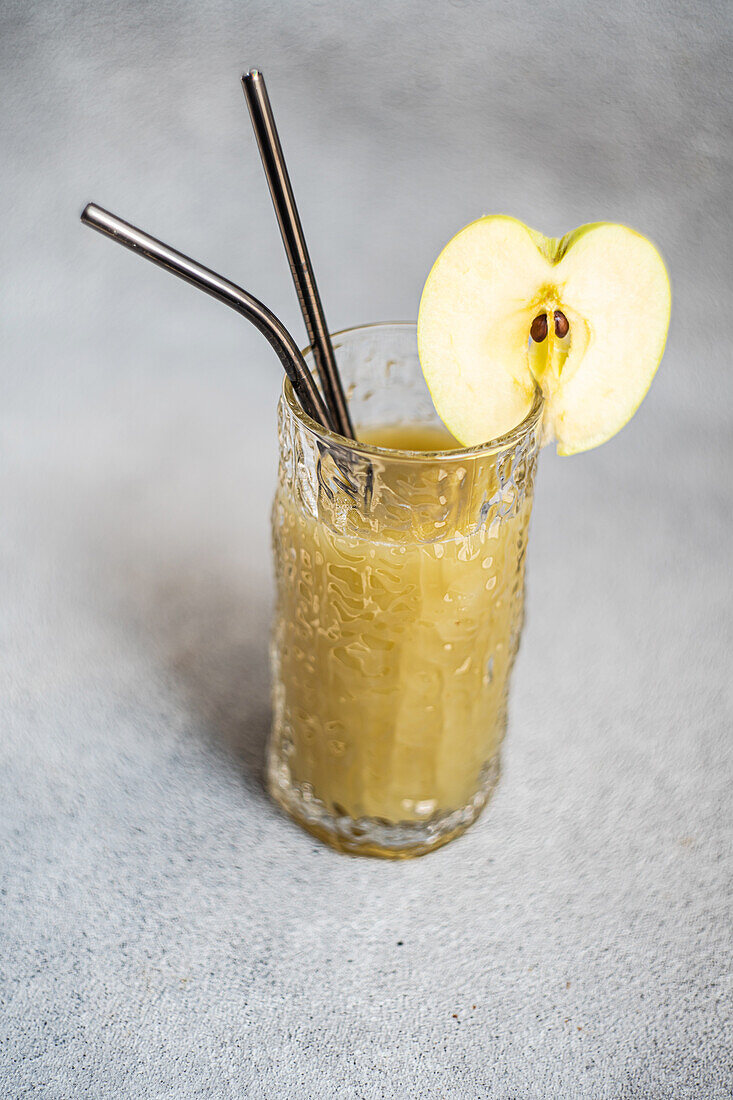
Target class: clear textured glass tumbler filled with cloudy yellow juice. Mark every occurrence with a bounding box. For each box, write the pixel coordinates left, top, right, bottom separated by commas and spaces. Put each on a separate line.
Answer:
267, 325, 541, 858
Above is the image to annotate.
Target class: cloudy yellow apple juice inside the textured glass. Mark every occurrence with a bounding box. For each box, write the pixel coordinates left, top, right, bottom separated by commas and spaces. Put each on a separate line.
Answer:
271, 426, 530, 847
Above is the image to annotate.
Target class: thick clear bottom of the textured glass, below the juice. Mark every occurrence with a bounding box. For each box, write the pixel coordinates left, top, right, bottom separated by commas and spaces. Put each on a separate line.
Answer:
267, 749, 501, 859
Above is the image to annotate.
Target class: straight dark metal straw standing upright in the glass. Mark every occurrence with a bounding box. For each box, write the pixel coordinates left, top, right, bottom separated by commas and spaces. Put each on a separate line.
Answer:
242, 69, 355, 439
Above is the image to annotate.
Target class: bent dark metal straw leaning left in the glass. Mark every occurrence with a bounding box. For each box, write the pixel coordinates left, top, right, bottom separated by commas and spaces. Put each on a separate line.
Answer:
81, 202, 333, 428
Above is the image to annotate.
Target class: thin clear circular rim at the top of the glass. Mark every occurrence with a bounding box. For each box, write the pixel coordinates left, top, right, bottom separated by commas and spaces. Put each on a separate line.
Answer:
283, 321, 544, 462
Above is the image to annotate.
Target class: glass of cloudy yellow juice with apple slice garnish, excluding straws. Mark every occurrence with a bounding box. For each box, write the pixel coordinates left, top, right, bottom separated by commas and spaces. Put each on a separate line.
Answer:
269, 216, 670, 858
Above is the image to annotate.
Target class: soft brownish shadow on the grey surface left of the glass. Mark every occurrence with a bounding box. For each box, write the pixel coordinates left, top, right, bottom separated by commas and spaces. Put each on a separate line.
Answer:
94, 514, 271, 798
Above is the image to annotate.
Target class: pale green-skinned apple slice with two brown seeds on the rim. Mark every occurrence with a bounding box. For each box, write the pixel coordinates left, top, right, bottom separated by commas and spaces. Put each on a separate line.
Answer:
417, 216, 670, 454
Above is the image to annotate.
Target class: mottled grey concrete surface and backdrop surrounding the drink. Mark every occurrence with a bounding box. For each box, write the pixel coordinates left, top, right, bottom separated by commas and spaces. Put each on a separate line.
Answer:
0, 0, 733, 1100
